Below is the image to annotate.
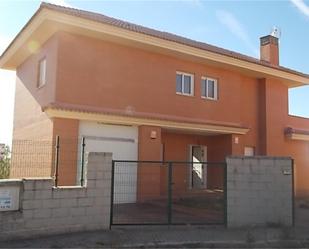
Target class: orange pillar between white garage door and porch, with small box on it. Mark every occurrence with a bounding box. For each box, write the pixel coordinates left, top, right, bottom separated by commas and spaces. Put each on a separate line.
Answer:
137, 125, 161, 201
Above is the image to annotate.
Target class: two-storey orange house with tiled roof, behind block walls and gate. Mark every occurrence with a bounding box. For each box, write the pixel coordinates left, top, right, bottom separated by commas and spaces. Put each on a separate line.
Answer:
0, 3, 309, 199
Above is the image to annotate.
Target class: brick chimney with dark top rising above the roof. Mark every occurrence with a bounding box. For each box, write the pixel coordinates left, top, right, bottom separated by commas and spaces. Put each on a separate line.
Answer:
260, 35, 279, 66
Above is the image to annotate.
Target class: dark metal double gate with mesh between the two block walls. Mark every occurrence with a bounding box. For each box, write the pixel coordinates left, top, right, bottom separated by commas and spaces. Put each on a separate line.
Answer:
110, 160, 227, 226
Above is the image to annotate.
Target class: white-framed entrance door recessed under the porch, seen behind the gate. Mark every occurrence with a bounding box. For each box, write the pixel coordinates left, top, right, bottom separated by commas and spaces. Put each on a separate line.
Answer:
191, 145, 207, 189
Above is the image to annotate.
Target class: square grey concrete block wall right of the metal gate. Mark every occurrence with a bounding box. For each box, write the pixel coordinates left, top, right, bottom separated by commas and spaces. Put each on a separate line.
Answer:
226, 156, 293, 227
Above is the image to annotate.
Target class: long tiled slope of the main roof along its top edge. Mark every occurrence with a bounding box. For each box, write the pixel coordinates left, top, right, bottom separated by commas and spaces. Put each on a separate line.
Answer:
40, 2, 309, 78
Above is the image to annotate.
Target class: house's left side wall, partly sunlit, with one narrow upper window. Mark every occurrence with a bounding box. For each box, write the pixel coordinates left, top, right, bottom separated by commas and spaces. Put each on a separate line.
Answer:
10, 37, 58, 178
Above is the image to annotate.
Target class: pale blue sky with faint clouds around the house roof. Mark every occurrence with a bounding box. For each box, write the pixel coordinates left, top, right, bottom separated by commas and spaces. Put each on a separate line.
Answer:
0, 0, 309, 144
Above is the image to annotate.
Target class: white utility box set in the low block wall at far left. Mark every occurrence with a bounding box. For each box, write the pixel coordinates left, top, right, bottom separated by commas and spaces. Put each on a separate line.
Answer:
0, 185, 20, 212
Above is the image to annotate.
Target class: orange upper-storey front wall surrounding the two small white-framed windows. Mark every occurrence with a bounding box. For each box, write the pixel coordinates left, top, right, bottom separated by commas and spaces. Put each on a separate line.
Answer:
56, 33, 258, 135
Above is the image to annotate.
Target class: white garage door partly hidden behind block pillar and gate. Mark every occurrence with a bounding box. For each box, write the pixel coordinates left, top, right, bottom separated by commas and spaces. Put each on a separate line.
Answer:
79, 121, 138, 203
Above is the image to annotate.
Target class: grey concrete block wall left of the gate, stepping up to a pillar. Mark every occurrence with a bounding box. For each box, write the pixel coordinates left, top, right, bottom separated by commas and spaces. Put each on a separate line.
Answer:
0, 153, 112, 240
